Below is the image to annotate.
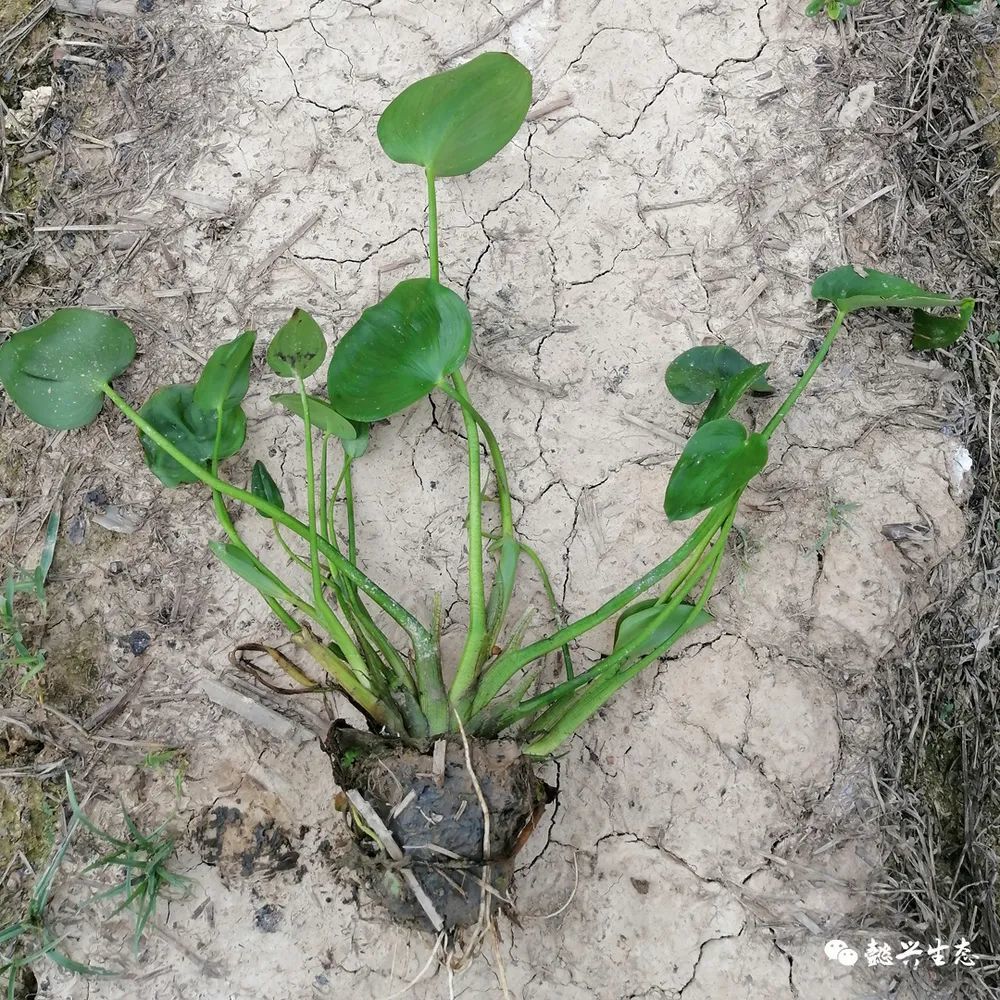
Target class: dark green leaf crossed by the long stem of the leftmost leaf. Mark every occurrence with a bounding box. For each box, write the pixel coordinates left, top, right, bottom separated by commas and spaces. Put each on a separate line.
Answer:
139, 385, 247, 487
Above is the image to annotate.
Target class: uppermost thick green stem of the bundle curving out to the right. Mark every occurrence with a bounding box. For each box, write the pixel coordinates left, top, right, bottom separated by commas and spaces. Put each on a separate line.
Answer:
473, 500, 732, 713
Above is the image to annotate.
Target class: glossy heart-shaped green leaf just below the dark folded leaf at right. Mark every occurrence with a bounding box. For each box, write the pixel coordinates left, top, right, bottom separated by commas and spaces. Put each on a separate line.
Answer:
663, 418, 767, 521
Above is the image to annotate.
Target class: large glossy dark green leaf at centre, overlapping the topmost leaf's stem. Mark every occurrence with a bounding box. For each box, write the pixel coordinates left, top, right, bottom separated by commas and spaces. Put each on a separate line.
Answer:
327, 278, 472, 423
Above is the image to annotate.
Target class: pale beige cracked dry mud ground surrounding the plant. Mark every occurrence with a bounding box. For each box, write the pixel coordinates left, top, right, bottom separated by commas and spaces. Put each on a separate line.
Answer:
41, 0, 976, 1000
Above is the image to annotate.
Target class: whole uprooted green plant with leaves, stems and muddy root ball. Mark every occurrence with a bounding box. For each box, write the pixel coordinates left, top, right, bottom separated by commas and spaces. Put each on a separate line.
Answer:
0, 53, 973, 935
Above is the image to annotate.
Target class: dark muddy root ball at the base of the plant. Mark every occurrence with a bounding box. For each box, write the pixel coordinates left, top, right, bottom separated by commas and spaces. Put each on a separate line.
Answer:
325, 721, 552, 932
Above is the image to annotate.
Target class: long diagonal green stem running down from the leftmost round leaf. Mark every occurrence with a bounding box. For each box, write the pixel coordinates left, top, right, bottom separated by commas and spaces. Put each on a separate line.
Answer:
101, 384, 434, 650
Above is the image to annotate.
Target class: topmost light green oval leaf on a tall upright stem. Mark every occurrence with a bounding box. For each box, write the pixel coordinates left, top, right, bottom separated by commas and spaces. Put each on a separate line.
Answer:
378, 52, 531, 177
